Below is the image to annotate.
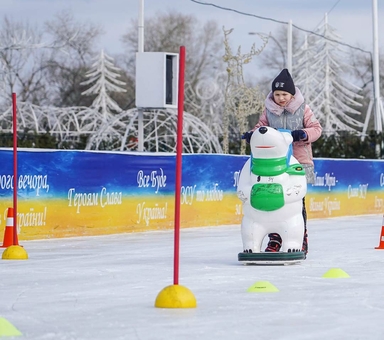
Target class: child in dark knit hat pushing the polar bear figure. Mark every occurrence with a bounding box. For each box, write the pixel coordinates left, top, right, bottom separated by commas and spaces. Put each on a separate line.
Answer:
242, 69, 322, 254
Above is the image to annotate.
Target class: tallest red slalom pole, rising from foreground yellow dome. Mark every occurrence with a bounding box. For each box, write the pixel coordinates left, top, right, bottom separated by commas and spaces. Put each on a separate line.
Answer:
173, 46, 185, 285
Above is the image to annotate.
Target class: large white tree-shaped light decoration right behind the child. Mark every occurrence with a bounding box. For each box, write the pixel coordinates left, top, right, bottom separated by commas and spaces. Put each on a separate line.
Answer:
293, 15, 363, 136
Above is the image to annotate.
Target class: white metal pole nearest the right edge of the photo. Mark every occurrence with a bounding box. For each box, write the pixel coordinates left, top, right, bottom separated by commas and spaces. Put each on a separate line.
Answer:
372, 0, 383, 132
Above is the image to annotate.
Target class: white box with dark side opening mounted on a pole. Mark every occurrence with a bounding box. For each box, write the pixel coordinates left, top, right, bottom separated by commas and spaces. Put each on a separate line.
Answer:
136, 52, 179, 108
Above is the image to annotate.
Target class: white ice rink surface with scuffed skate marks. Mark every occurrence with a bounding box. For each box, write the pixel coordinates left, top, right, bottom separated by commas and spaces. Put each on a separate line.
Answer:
0, 215, 384, 340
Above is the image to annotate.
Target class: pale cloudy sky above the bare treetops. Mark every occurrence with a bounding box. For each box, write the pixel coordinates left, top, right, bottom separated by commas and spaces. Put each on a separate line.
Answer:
0, 0, 384, 59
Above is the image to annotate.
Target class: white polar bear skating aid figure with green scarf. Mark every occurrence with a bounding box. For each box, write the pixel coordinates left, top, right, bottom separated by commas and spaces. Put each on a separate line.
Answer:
237, 126, 307, 253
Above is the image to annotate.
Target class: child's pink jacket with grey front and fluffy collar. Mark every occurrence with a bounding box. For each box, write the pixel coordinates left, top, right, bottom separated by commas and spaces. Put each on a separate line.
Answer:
252, 87, 323, 165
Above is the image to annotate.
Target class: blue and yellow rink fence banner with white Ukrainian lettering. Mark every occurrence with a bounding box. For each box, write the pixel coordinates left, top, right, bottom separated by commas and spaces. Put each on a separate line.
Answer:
0, 149, 384, 240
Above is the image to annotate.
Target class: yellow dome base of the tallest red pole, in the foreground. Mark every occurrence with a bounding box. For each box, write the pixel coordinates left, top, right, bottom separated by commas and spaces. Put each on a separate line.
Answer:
155, 285, 196, 308
